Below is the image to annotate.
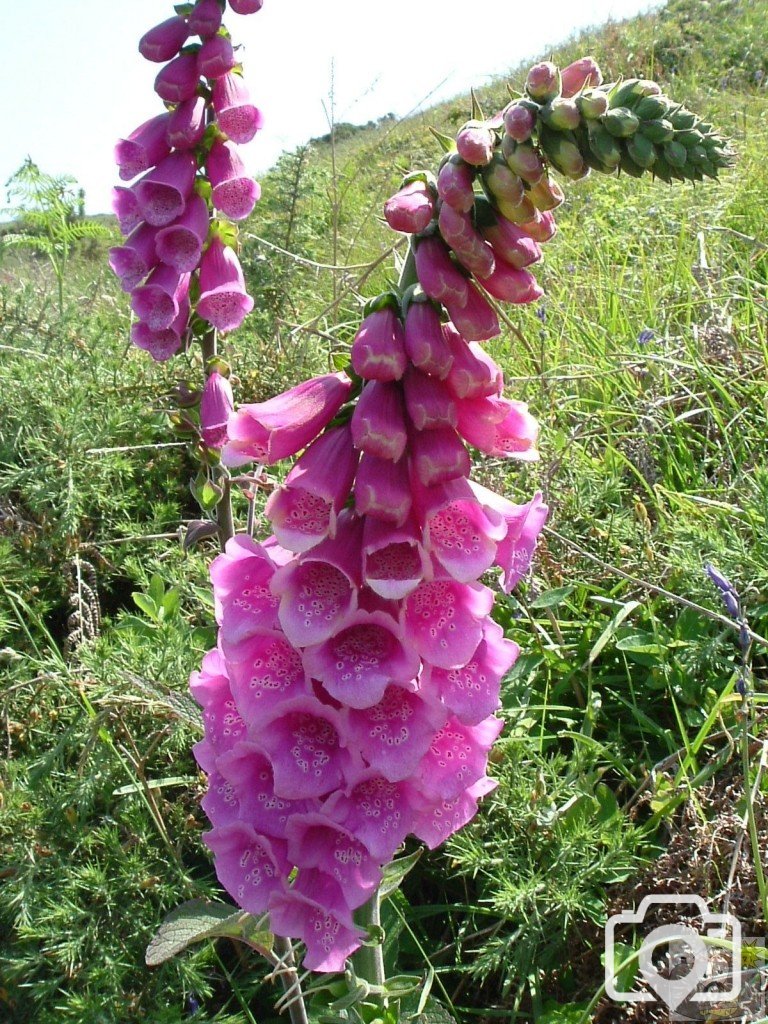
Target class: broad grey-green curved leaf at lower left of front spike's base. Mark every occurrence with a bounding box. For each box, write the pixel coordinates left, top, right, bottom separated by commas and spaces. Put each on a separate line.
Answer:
144, 899, 272, 967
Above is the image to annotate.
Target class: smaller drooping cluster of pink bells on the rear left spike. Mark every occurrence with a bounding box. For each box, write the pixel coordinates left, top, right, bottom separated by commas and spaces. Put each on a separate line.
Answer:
110, 0, 262, 360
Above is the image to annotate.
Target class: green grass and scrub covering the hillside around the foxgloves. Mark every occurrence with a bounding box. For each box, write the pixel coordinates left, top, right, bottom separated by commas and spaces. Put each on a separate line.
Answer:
0, 0, 768, 1024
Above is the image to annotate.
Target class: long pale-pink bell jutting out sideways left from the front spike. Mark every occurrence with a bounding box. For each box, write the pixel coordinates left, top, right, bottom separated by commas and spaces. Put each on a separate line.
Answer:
224, 370, 352, 466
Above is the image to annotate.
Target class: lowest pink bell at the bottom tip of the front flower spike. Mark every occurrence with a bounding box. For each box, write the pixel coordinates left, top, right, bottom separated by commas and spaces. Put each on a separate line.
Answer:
268, 892, 366, 973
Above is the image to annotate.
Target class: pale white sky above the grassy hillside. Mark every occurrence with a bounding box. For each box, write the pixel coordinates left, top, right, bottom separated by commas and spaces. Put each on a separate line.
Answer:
0, 0, 659, 213
